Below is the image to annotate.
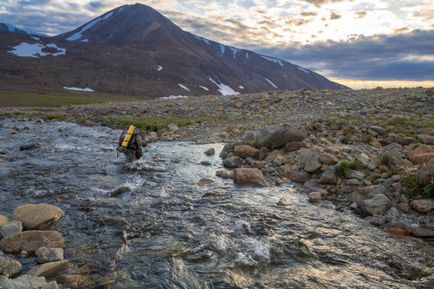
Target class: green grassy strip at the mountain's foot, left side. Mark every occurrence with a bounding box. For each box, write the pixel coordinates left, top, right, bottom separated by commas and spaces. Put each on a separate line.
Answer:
0, 91, 143, 107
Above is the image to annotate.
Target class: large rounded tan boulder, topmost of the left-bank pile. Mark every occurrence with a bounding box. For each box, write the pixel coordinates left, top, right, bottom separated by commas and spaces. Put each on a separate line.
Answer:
13, 204, 65, 230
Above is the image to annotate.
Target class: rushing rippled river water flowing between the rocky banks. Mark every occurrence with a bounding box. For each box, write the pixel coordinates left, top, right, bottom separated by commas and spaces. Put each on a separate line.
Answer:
0, 120, 434, 288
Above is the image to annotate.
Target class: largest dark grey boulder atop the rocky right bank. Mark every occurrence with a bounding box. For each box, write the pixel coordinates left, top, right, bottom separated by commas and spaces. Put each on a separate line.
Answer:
256, 124, 307, 149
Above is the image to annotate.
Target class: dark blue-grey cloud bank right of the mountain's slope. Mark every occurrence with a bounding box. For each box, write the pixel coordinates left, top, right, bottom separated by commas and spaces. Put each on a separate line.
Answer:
258, 30, 434, 81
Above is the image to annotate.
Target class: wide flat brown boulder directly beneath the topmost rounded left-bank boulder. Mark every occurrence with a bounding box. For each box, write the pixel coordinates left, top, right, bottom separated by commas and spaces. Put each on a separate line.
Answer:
0, 231, 65, 254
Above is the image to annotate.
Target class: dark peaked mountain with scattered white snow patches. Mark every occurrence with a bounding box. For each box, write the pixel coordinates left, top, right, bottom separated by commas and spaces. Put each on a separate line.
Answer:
0, 4, 346, 96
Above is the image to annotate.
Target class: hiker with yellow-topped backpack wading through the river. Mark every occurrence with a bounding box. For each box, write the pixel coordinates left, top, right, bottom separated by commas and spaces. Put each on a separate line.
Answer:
116, 125, 145, 162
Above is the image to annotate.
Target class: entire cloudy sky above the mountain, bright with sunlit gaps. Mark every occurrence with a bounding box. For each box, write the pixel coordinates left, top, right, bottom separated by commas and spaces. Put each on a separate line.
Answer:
0, 0, 434, 88
